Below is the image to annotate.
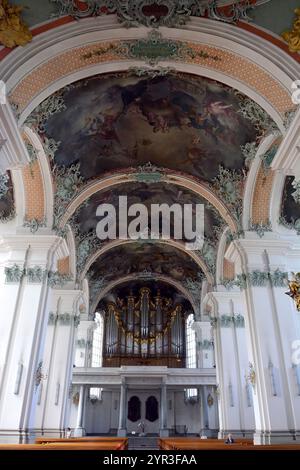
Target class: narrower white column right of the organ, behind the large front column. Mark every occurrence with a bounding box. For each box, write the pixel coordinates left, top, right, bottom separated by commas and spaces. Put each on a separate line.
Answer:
210, 291, 254, 439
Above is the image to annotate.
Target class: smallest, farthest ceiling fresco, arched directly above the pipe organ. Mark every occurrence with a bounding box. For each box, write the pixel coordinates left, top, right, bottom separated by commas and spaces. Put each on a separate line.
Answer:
89, 241, 202, 282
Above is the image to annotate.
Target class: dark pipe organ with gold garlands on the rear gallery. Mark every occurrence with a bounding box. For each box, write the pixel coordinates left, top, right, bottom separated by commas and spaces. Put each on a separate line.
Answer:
103, 287, 185, 367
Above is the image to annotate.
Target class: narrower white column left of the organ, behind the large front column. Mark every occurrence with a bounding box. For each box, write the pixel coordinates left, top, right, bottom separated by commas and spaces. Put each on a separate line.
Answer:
36, 289, 81, 436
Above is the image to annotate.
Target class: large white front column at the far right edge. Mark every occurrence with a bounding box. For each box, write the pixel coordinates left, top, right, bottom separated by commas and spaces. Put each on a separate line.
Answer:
226, 239, 300, 444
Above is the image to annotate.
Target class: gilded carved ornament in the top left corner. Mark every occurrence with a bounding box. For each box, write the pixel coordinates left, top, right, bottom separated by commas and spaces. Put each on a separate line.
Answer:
0, 0, 32, 48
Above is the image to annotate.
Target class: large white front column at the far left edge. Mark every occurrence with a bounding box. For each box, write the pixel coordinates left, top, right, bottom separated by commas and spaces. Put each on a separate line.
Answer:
0, 234, 67, 442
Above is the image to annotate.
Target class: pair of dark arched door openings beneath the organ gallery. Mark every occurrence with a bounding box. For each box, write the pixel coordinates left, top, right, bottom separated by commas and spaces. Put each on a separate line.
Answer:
127, 390, 160, 435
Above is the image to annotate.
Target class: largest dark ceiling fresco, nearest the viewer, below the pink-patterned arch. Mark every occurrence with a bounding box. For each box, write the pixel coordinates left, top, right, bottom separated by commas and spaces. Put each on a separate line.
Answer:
43, 73, 257, 181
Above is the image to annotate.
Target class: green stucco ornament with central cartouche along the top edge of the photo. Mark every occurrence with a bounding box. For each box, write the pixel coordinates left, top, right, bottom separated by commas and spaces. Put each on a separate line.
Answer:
52, 0, 270, 27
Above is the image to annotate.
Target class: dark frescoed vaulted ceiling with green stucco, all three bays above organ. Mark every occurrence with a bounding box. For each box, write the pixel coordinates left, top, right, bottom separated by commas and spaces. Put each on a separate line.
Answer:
26, 70, 274, 312
